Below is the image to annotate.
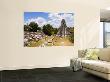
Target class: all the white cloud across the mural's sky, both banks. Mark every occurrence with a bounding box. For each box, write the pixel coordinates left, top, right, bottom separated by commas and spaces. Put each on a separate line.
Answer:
25, 13, 74, 28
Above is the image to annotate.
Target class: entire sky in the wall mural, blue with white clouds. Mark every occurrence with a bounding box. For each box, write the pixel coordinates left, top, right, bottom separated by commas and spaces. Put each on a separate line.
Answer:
24, 12, 74, 28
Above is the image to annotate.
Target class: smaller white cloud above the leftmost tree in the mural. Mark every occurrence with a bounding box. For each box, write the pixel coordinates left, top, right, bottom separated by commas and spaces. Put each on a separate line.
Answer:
25, 17, 47, 27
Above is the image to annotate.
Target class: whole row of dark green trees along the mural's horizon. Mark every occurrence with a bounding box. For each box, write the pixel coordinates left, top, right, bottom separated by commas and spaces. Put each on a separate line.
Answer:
24, 22, 74, 36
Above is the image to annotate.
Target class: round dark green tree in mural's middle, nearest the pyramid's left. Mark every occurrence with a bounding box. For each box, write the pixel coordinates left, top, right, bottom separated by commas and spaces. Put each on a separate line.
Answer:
42, 24, 54, 36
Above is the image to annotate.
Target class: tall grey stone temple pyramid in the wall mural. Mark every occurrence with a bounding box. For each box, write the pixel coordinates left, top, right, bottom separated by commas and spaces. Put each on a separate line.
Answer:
57, 19, 69, 37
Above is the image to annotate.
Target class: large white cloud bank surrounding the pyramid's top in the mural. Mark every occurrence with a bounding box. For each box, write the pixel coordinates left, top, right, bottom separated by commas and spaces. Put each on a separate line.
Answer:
48, 13, 74, 28
